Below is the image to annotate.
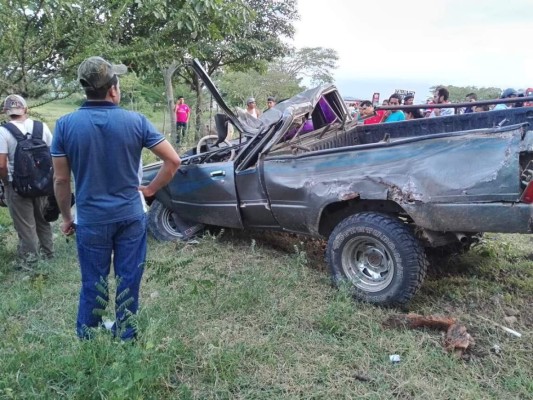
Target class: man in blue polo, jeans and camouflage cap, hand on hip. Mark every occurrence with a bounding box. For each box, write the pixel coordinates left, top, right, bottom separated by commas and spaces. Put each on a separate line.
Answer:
51, 57, 181, 340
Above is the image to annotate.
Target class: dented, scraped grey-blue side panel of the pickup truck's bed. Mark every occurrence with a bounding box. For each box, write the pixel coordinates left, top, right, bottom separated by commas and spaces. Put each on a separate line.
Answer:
264, 126, 531, 235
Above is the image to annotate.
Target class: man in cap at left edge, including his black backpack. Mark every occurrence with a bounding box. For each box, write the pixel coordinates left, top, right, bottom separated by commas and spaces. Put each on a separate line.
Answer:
0, 94, 54, 266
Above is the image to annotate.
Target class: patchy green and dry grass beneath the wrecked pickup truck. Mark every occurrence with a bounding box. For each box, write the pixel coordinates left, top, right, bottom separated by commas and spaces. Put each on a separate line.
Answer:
0, 101, 533, 400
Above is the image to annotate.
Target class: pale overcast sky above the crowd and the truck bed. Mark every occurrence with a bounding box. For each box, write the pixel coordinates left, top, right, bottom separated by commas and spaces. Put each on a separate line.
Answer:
295, 0, 533, 102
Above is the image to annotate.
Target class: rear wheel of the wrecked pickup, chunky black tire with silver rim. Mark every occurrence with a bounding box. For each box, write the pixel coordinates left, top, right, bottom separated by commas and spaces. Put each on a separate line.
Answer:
326, 212, 428, 306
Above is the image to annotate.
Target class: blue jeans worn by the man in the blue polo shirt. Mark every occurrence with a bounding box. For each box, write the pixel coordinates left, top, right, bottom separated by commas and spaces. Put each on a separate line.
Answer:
76, 214, 146, 340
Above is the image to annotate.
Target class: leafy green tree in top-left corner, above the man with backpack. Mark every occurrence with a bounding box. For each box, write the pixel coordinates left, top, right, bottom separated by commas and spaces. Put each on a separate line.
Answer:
0, 0, 100, 97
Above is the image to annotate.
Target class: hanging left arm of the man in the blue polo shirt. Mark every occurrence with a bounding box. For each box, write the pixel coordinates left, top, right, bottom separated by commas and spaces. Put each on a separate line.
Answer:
52, 157, 74, 236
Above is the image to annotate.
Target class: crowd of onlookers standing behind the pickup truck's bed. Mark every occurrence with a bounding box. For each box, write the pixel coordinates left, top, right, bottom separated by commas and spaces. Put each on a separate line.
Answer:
348, 87, 524, 125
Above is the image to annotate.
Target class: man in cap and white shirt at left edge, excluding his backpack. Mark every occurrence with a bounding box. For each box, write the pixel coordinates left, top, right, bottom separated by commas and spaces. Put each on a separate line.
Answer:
0, 94, 54, 269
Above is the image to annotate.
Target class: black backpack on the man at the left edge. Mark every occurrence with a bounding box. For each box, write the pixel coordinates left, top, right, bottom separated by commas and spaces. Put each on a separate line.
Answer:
3, 121, 54, 197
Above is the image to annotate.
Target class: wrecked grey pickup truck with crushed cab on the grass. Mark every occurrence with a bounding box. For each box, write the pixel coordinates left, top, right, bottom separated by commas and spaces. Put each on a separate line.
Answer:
143, 61, 533, 305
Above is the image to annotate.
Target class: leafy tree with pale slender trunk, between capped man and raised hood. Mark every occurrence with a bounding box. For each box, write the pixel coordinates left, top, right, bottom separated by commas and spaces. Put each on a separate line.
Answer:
105, 0, 250, 141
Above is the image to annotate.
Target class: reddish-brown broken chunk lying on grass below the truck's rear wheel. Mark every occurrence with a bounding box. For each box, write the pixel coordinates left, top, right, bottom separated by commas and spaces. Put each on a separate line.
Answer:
383, 313, 474, 361
